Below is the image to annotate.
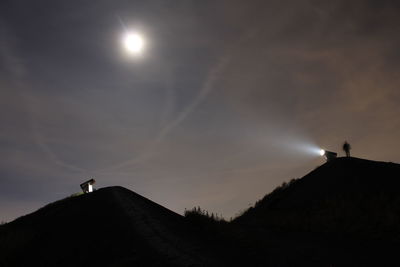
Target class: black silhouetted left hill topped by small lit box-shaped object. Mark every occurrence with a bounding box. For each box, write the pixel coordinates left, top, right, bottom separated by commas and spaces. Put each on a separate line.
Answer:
0, 187, 222, 266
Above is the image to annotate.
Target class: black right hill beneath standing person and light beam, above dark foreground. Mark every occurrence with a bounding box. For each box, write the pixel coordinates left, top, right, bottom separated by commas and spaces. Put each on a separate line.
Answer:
236, 158, 400, 238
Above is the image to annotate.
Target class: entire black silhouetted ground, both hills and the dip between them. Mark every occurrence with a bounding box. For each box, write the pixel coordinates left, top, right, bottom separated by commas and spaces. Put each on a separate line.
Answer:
0, 158, 400, 266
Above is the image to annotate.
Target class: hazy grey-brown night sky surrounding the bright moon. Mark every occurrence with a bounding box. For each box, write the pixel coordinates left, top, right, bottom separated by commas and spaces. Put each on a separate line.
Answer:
0, 0, 400, 221
